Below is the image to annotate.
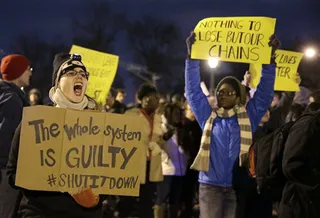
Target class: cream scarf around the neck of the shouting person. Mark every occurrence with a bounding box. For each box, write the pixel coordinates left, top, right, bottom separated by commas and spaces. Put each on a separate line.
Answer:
49, 87, 89, 110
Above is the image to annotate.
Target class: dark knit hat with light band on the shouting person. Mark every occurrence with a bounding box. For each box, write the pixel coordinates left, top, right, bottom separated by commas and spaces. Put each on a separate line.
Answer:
52, 53, 87, 86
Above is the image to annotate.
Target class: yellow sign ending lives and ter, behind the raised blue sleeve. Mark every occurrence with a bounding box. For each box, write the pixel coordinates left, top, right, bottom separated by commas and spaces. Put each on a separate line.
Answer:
249, 50, 303, 91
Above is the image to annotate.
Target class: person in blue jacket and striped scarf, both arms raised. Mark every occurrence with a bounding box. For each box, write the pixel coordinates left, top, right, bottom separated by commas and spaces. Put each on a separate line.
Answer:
185, 32, 280, 218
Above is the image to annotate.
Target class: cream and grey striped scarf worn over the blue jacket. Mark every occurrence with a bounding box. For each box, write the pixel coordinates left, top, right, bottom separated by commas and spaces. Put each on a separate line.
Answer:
191, 106, 252, 172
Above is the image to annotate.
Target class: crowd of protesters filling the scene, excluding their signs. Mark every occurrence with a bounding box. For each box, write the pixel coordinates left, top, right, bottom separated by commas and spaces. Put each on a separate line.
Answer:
0, 30, 320, 218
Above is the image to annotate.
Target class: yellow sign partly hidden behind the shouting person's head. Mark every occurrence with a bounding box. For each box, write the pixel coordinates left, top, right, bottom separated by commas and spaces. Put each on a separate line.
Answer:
70, 45, 119, 104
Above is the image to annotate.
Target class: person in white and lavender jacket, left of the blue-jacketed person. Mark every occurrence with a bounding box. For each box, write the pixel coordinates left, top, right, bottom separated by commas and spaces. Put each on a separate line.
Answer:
154, 94, 187, 218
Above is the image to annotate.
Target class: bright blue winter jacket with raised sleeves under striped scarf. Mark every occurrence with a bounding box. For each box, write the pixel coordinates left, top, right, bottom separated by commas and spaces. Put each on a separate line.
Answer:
185, 60, 275, 187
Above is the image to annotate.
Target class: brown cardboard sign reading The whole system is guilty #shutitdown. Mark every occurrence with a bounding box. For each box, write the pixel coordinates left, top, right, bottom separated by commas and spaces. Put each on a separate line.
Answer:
16, 106, 146, 196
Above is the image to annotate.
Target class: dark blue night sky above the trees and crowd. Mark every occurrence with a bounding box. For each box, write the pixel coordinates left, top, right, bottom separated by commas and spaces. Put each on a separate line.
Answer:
0, 0, 320, 101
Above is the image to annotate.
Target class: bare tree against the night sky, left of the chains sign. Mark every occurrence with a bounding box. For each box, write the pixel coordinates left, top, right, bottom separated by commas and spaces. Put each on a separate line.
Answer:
127, 16, 184, 90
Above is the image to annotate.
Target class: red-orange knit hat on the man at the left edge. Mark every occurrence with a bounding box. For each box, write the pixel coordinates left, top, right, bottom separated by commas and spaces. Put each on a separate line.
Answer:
0, 54, 30, 81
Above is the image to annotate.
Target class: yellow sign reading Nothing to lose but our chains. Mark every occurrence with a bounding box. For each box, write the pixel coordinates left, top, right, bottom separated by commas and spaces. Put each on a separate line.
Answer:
191, 17, 276, 64
